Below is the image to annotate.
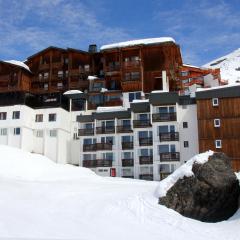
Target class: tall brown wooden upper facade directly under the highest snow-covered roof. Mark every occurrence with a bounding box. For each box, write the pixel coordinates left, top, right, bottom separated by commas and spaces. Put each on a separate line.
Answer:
102, 43, 182, 93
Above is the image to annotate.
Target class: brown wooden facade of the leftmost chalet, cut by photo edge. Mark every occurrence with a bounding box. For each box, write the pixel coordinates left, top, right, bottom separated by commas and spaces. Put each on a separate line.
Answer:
0, 61, 32, 92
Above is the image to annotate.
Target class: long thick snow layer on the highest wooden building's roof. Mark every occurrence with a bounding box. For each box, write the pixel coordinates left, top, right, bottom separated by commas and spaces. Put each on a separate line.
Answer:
100, 37, 175, 51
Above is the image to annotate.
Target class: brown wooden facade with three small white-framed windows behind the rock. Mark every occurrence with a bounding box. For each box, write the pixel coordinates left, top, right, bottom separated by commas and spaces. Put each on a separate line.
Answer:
197, 87, 240, 171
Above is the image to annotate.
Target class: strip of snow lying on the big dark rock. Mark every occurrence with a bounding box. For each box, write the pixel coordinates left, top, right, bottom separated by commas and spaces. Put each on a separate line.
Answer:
157, 151, 214, 197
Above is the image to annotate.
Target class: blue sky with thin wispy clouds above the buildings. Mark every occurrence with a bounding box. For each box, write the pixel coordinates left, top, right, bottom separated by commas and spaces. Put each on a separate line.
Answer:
0, 0, 240, 65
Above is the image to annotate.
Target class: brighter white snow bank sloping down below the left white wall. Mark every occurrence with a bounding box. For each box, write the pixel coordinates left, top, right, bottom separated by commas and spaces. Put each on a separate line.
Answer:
0, 145, 95, 181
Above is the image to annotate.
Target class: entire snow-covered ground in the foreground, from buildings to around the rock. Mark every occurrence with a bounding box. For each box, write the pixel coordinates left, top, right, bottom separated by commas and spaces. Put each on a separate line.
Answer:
0, 146, 240, 240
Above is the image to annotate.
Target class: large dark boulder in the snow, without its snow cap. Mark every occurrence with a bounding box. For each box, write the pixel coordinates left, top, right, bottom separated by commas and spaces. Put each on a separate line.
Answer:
159, 153, 240, 222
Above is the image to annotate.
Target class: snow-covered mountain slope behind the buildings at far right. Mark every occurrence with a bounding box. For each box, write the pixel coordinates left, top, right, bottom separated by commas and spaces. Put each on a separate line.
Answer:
203, 48, 240, 84
